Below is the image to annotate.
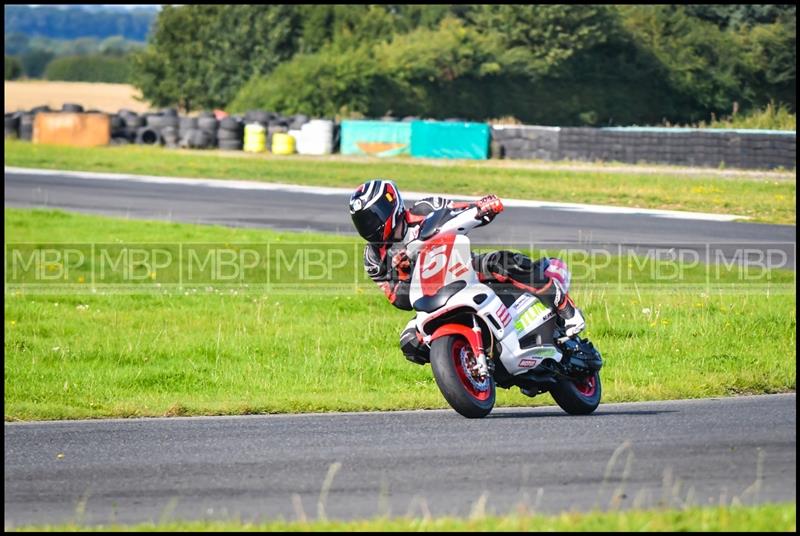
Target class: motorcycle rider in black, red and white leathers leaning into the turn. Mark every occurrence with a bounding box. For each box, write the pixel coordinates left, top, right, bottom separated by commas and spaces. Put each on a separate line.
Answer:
350, 179, 586, 365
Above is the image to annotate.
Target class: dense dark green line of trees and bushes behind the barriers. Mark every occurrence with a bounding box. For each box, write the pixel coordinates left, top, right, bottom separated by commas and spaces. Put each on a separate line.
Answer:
132, 5, 796, 125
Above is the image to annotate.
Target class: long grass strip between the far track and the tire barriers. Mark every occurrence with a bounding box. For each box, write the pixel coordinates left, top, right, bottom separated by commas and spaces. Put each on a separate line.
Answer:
4, 140, 797, 224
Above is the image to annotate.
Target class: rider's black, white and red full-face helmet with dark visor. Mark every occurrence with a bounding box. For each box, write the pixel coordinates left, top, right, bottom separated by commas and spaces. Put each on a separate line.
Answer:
350, 179, 407, 243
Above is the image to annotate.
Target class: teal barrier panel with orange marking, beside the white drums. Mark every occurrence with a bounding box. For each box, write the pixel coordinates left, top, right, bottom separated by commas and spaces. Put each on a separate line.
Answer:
339, 120, 411, 156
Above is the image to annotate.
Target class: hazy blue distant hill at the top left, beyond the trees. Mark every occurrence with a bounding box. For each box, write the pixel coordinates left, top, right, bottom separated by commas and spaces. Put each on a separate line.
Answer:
3, 4, 158, 41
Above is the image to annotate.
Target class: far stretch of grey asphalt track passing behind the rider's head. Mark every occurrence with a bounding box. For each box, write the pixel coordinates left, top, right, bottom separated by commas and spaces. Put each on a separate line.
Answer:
5, 171, 796, 269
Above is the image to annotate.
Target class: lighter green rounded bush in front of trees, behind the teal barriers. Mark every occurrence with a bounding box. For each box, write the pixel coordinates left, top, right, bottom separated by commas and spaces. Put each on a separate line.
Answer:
228, 19, 499, 119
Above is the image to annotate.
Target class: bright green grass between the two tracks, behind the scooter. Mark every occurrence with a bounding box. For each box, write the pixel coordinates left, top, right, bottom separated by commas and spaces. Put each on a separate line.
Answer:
4, 208, 796, 421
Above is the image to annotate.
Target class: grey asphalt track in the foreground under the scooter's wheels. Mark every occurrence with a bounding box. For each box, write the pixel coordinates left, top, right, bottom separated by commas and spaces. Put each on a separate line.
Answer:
5, 394, 797, 529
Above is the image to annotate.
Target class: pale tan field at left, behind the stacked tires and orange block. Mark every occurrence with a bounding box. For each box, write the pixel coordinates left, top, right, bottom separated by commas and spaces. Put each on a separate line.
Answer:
4, 80, 151, 113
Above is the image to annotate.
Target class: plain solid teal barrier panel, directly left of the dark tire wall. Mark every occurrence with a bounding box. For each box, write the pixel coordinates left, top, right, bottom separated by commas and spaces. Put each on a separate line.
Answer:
411, 121, 490, 160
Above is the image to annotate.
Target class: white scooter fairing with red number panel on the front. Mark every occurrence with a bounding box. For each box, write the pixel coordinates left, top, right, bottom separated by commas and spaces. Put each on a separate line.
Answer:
407, 209, 561, 375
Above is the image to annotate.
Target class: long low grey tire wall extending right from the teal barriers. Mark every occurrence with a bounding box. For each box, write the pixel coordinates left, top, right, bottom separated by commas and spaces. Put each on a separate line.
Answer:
492, 125, 797, 169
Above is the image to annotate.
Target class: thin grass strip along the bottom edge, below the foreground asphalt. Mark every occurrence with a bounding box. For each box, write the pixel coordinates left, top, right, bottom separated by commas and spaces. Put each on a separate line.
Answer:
13, 504, 797, 532
